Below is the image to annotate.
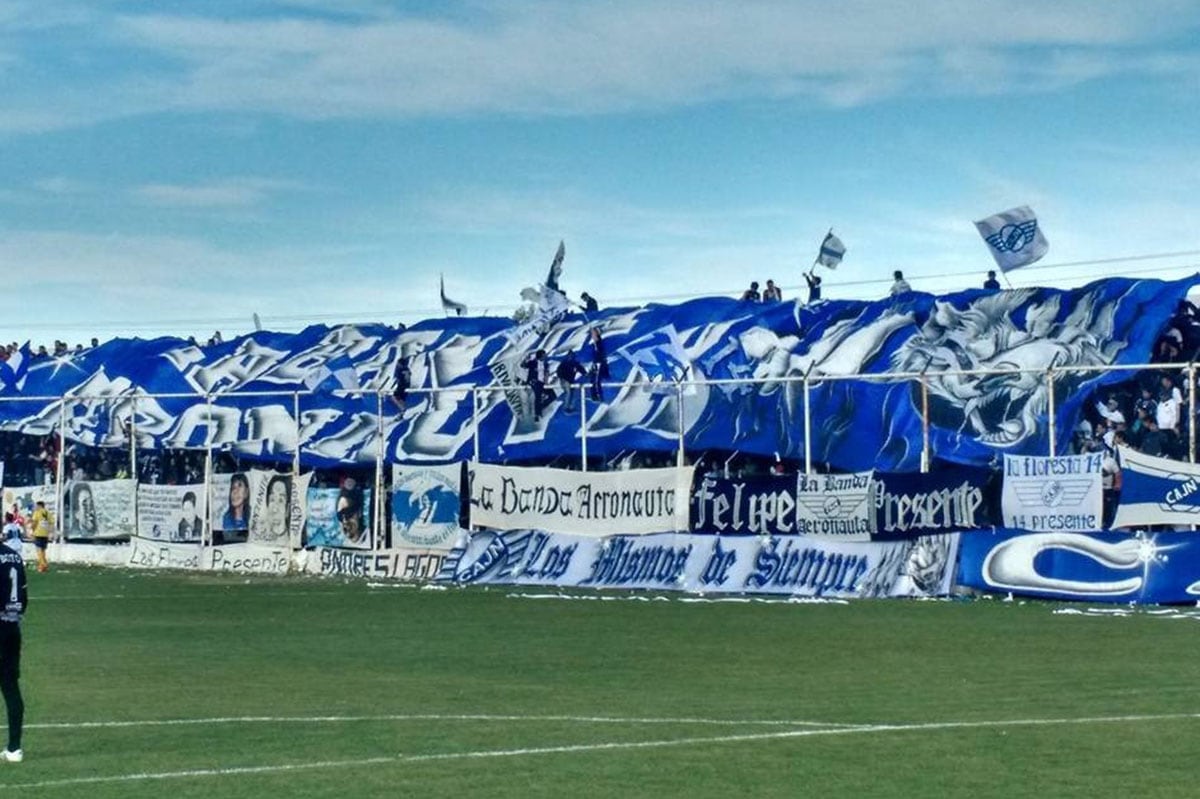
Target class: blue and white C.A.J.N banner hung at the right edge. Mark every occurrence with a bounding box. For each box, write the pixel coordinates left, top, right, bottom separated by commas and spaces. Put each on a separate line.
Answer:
1112, 446, 1200, 527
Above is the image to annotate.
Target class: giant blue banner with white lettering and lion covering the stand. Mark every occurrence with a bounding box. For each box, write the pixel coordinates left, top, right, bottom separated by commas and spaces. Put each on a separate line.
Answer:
0, 277, 1198, 471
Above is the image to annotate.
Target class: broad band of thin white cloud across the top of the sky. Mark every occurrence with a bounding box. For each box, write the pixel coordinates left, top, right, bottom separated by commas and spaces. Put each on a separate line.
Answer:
0, 0, 1200, 131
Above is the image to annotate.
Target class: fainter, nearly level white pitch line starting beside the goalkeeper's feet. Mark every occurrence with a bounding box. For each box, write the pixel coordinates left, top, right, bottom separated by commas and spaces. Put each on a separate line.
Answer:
25, 713, 870, 729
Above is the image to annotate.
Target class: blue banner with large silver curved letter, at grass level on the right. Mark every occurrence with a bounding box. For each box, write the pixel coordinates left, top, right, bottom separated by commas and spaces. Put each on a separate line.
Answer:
958, 530, 1200, 605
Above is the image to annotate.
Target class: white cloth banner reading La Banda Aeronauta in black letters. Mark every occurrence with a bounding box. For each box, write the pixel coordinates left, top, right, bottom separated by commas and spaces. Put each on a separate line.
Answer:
467, 463, 692, 535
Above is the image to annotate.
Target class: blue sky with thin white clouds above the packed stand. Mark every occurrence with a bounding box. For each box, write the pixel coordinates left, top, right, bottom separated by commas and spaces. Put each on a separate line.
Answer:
0, 0, 1200, 346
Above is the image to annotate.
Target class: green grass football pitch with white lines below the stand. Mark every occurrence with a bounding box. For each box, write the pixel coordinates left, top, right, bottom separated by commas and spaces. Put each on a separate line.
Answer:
0, 567, 1200, 799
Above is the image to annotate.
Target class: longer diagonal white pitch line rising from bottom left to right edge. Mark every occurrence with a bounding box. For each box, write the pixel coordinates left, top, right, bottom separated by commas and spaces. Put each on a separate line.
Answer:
9, 713, 1200, 788
